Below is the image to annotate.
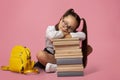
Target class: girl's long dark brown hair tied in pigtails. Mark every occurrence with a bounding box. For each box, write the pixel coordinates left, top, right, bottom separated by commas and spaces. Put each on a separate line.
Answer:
55, 9, 88, 67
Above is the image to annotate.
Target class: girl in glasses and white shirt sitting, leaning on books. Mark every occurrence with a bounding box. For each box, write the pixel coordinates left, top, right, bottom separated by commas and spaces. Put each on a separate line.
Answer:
34, 9, 92, 72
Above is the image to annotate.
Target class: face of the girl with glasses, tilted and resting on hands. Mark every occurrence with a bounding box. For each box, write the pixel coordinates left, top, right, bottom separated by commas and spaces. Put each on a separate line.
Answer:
59, 15, 78, 32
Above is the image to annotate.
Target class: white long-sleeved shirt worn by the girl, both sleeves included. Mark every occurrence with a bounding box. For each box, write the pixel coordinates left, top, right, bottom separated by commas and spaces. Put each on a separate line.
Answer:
46, 26, 86, 54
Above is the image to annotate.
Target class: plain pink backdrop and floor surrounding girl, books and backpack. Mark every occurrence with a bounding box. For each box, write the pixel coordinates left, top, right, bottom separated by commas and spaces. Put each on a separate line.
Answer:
0, 0, 120, 80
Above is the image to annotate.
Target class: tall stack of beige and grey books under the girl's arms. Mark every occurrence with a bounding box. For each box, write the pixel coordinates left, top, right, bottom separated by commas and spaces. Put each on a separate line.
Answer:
53, 38, 84, 76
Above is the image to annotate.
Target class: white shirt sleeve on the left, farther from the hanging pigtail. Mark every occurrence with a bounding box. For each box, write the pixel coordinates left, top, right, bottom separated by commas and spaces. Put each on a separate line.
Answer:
46, 26, 64, 39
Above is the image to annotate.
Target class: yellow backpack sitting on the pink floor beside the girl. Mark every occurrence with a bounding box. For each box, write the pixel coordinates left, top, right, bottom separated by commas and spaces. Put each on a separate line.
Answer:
1, 45, 38, 74
